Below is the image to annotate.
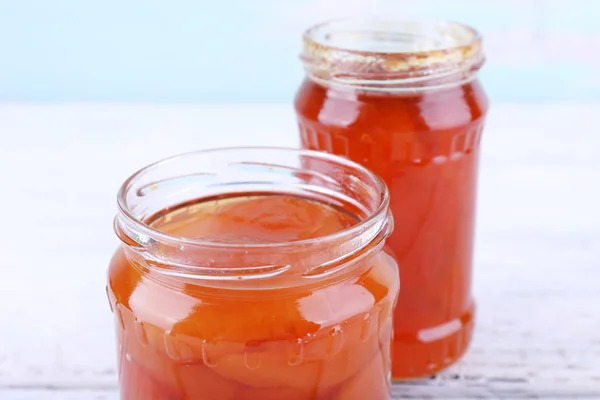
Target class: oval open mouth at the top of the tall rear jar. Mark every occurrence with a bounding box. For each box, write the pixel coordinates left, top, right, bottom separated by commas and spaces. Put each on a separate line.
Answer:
303, 18, 482, 57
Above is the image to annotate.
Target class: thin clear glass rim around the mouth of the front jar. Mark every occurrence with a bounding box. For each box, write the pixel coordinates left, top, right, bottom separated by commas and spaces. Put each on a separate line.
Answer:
115, 146, 390, 250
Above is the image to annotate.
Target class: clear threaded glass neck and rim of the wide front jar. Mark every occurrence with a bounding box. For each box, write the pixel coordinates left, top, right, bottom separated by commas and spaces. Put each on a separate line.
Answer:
115, 148, 393, 290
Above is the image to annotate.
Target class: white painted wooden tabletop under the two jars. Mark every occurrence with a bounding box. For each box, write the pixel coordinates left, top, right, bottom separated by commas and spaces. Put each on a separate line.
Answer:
0, 104, 600, 400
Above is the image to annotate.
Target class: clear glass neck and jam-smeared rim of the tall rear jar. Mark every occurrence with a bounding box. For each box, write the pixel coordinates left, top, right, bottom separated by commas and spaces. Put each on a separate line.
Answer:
301, 20, 484, 93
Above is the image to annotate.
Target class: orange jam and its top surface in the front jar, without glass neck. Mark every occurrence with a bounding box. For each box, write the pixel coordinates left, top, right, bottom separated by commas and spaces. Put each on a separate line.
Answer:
108, 195, 399, 400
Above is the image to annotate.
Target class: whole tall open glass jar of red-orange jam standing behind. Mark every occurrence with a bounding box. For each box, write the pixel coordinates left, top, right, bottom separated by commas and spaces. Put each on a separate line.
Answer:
295, 20, 488, 379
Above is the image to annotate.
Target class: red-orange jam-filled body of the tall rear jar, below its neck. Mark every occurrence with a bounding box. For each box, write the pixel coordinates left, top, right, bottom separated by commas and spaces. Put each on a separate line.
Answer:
295, 78, 488, 379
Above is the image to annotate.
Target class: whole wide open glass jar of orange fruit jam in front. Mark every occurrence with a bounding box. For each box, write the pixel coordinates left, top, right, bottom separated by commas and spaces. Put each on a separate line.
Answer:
107, 148, 399, 400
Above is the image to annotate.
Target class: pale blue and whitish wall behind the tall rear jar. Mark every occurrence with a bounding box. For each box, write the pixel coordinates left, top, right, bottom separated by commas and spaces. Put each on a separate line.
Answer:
0, 0, 600, 103
